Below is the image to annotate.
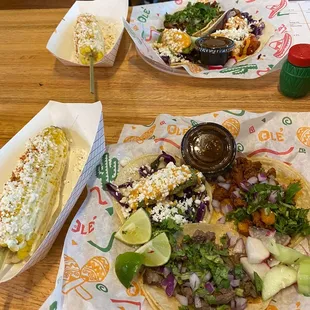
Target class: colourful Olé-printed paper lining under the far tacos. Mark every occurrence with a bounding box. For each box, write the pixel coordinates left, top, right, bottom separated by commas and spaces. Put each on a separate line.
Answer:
124, 0, 293, 79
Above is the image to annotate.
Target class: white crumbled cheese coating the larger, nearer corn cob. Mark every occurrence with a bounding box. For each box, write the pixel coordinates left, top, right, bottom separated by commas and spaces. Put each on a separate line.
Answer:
0, 128, 66, 252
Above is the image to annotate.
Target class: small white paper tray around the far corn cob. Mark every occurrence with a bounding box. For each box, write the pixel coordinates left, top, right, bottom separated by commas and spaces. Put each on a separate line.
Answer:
46, 0, 128, 67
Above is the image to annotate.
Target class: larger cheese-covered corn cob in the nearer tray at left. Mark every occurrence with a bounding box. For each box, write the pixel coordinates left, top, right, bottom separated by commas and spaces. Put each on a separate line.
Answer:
0, 127, 69, 261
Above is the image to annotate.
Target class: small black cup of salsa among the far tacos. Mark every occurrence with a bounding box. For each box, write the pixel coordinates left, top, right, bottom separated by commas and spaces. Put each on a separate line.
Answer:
195, 36, 235, 66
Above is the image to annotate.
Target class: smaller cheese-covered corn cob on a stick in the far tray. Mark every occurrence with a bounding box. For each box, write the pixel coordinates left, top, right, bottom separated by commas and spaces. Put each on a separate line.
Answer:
74, 14, 105, 65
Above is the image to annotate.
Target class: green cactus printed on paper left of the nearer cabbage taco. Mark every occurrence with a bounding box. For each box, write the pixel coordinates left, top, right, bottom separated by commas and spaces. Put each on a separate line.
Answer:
96, 153, 119, 189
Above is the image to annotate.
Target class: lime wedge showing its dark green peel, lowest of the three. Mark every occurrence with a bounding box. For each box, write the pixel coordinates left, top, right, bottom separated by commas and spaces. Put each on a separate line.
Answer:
115, 252, 143, 288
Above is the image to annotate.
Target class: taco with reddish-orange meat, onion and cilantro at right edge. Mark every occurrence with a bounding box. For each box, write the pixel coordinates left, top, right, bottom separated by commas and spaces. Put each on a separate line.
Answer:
211, 157, 310, 246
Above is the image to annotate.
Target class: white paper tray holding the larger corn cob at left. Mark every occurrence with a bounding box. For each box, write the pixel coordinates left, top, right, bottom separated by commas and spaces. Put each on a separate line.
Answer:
0, 101, 105, 282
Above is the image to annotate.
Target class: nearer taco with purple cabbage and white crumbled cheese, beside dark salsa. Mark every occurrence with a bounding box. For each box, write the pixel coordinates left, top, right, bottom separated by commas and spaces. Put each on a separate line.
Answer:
107, 152, 212, 225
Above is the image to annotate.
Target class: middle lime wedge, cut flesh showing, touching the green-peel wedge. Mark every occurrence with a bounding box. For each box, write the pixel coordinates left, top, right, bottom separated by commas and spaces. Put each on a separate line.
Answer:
136, 233, 171, 267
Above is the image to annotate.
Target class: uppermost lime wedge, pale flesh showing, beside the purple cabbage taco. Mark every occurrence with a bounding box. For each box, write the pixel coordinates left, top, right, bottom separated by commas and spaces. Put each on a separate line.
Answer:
115, 208, 152, 245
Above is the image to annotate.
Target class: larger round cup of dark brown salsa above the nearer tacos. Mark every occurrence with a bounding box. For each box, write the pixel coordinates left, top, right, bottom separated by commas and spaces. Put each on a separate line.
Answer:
181, 123, 237, 177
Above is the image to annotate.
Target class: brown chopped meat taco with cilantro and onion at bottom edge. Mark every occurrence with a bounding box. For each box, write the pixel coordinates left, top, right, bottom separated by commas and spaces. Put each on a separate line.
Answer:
141, 223, 269, 310
